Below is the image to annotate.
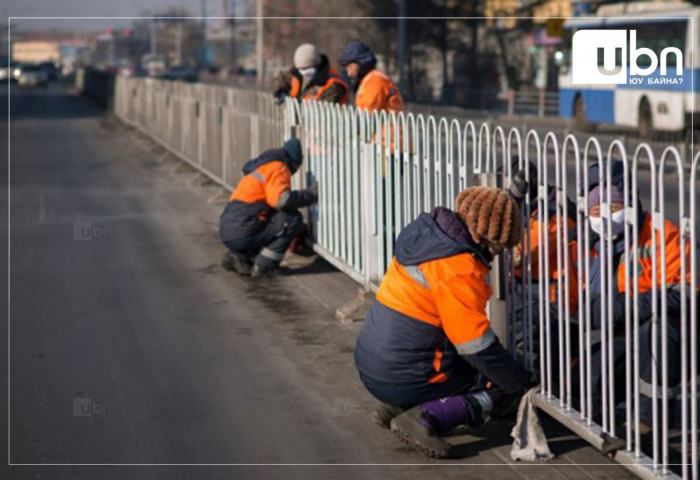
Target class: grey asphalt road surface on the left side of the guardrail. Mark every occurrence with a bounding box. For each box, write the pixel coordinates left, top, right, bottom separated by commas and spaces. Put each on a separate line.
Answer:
0, 86, 628, 480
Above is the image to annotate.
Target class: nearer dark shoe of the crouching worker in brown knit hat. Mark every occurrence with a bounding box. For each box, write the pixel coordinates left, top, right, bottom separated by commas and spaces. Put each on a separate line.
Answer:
391, 405, 452, 458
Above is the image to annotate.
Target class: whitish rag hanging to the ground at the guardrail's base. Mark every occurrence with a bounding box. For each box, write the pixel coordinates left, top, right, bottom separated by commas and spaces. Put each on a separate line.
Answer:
510, 387, 554, 462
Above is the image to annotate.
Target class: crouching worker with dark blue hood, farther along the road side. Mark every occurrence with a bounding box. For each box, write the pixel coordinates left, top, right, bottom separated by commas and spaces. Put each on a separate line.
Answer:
219, 138, 317, 277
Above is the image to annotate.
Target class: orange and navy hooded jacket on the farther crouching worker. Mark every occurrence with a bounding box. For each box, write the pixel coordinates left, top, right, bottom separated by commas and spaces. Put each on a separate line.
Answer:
219, 148, 316, 242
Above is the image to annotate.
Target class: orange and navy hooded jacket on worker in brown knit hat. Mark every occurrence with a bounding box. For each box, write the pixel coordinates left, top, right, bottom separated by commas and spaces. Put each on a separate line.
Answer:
355, 208, 529, 392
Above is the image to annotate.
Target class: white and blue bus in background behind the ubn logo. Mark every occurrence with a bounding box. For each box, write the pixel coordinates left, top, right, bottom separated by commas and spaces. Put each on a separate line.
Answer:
557, 2, 700, 136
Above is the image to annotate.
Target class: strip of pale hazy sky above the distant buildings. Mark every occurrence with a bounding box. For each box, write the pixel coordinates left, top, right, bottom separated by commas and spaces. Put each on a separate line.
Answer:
0, 0, 249, 31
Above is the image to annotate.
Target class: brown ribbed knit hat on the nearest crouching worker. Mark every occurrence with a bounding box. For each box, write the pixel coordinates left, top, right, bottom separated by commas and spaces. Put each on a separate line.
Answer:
455, 187, 520, 255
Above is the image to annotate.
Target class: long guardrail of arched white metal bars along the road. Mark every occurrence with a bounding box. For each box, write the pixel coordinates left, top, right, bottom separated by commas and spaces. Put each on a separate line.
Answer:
114, 77, 700, 480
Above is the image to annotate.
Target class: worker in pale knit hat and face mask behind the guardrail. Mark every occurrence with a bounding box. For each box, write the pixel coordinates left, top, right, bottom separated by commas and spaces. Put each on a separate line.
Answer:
274, 43, 348, 104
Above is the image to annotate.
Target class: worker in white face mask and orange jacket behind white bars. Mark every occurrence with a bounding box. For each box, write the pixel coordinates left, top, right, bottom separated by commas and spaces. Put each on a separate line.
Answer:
572, 160, 697, 428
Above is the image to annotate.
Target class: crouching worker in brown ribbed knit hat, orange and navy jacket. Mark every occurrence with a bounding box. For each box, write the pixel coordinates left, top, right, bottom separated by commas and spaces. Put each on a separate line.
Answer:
355, 187, 532, 457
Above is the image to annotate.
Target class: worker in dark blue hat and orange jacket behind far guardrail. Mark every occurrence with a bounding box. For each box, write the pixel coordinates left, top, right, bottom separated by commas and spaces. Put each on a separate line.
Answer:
338, 42, 403, 113
